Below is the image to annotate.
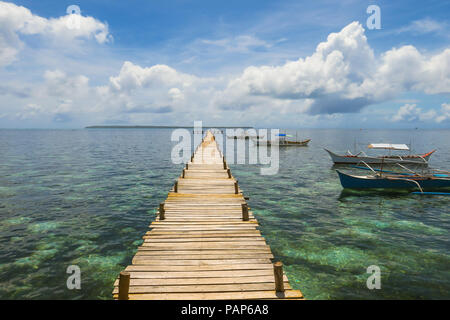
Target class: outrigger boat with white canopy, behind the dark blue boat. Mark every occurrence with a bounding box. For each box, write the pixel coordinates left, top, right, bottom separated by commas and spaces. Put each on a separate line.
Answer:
325, 143, 436, 165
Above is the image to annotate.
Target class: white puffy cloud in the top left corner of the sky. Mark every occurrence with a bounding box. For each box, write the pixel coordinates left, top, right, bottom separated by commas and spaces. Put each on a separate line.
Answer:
0, 1, 112, 67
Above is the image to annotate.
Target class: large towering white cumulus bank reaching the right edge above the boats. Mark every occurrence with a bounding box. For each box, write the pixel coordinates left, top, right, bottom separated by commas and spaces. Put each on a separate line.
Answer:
217, 22, 450, 114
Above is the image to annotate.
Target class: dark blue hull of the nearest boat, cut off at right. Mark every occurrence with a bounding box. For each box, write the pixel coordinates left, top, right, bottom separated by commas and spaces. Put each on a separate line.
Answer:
336, 170, 450, 189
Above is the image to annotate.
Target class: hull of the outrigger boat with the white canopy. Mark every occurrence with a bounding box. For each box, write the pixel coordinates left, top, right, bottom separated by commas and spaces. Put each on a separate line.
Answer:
325, 149, 434, 164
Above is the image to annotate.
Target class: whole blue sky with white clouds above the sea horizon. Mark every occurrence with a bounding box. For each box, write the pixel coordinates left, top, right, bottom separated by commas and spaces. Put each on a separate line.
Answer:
0, 0, 450, 128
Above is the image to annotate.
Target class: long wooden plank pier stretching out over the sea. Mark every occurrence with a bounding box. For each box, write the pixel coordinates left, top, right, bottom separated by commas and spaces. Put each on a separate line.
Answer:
113, 131, 303, 300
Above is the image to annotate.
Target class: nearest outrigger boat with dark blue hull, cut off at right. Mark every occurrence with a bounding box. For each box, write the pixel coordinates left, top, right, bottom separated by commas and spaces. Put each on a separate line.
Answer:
336, 163, 450, 195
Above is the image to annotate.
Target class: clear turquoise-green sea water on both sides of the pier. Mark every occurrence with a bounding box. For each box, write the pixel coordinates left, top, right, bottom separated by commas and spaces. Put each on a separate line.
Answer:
0, 129, 450, 299
